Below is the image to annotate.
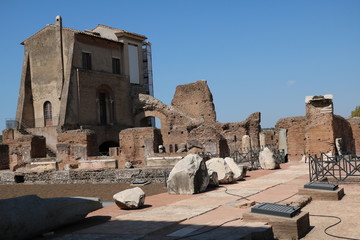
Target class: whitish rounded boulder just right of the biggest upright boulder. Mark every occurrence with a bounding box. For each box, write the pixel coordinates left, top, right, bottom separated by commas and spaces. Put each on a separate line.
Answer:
206, 158, 234, 183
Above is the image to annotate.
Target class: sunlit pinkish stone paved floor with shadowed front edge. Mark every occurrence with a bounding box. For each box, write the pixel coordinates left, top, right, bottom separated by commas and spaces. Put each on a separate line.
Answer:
46, 163, 360, 240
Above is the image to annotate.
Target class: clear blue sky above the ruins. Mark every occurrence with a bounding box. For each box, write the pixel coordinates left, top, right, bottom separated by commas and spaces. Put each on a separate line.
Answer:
0, 0, 360, 129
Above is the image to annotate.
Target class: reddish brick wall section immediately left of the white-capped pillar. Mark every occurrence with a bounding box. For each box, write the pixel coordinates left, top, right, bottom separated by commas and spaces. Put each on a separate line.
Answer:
275, 117, 307, 161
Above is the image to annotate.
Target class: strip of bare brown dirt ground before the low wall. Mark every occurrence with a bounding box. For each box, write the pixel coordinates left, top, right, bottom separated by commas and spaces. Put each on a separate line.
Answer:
0, 183, 166, 202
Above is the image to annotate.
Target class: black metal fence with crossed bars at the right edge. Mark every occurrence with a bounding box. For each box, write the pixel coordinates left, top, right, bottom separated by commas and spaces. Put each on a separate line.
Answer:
308, 153, 360, 182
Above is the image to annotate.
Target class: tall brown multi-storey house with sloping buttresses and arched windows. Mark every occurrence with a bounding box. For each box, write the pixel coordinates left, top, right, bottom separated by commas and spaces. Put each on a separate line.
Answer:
16, 16, 152, 155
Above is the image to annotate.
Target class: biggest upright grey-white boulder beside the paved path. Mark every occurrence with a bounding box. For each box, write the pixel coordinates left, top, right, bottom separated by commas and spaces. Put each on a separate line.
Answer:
167, 154, 210, 194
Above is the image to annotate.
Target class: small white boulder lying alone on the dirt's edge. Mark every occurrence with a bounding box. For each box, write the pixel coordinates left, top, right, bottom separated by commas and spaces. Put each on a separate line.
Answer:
113, 187, 145, 209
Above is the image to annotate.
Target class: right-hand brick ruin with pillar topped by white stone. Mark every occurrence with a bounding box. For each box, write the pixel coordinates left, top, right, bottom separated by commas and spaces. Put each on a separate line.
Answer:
275, 95, 360, 160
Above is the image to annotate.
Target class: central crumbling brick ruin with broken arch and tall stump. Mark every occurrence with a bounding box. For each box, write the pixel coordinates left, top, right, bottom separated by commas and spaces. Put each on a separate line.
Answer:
119, 80, 260, 167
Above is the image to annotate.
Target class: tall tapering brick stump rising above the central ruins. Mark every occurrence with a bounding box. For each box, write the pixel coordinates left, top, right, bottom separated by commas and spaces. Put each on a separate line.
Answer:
171, 80, 216, 122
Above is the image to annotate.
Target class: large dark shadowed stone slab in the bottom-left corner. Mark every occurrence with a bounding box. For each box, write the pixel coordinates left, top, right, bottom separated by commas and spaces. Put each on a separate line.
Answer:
0, 195, 102, 239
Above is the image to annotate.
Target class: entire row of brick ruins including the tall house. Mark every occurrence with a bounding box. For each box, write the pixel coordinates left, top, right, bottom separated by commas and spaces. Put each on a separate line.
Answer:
0, 16, 360, 177
